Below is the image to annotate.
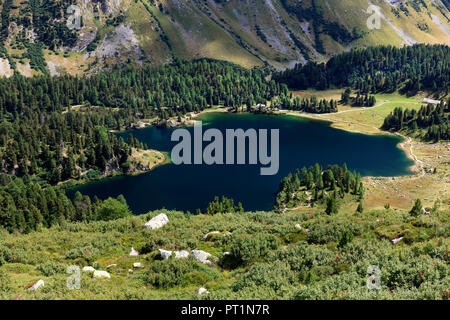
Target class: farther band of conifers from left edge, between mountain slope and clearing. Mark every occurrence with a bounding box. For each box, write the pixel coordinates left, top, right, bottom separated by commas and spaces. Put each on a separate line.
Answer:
0, 59, 282, 119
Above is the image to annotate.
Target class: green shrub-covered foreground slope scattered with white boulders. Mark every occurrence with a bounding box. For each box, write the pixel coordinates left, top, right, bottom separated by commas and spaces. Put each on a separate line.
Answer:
0, 204, 450, 300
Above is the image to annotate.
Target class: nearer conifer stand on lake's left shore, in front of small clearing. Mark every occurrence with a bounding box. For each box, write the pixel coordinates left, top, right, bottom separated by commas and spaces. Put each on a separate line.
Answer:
0, 111, 146, 185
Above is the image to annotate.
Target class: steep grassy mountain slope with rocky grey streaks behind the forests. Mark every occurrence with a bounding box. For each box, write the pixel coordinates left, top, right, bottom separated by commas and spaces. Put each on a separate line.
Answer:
0, 0, 450, 76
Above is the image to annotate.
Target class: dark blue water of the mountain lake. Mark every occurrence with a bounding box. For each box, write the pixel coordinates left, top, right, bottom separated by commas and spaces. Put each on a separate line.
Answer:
67, 113, 413, 214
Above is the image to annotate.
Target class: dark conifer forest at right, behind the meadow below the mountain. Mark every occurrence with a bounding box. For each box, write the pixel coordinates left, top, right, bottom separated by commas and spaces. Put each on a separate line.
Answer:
274, 44, 450, 95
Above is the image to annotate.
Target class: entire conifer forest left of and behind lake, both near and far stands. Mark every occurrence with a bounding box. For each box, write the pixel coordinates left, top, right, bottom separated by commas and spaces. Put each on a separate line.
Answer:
0, 60, 286, 188
